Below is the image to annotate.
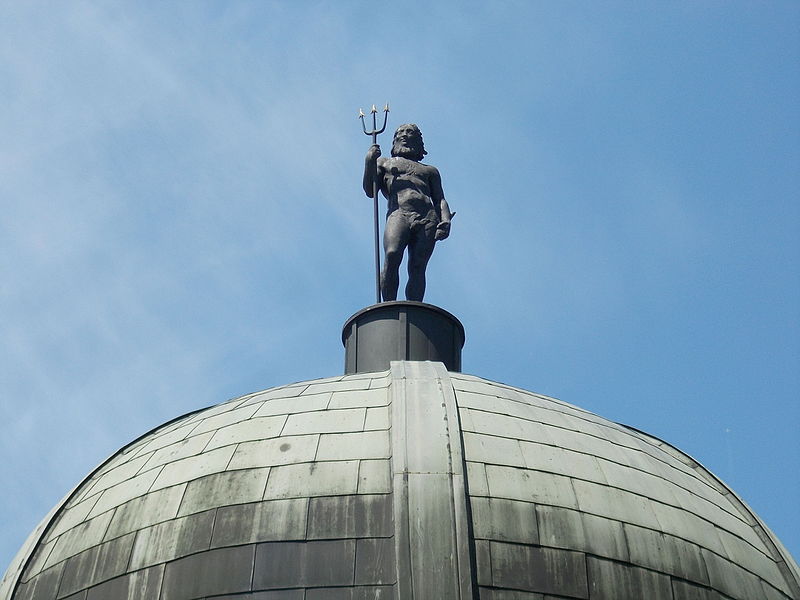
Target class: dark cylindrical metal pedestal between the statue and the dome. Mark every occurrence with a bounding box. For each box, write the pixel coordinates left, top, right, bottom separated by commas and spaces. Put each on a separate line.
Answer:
342, 301, 464, 374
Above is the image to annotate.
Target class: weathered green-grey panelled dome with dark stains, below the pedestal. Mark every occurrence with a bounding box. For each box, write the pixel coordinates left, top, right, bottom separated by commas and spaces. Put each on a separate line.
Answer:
0, 361, 800, 600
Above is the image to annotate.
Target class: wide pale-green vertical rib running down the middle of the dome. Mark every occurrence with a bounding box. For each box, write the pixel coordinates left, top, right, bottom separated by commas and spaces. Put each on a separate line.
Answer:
391, 361, 475, 600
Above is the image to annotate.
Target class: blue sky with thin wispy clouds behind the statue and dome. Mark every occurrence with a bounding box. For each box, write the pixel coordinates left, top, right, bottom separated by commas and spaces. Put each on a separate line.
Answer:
0, 1, 800, 568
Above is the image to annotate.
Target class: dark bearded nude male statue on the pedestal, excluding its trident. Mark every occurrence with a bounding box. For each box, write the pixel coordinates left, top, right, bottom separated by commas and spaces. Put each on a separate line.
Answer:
364, 123, 455, 302
